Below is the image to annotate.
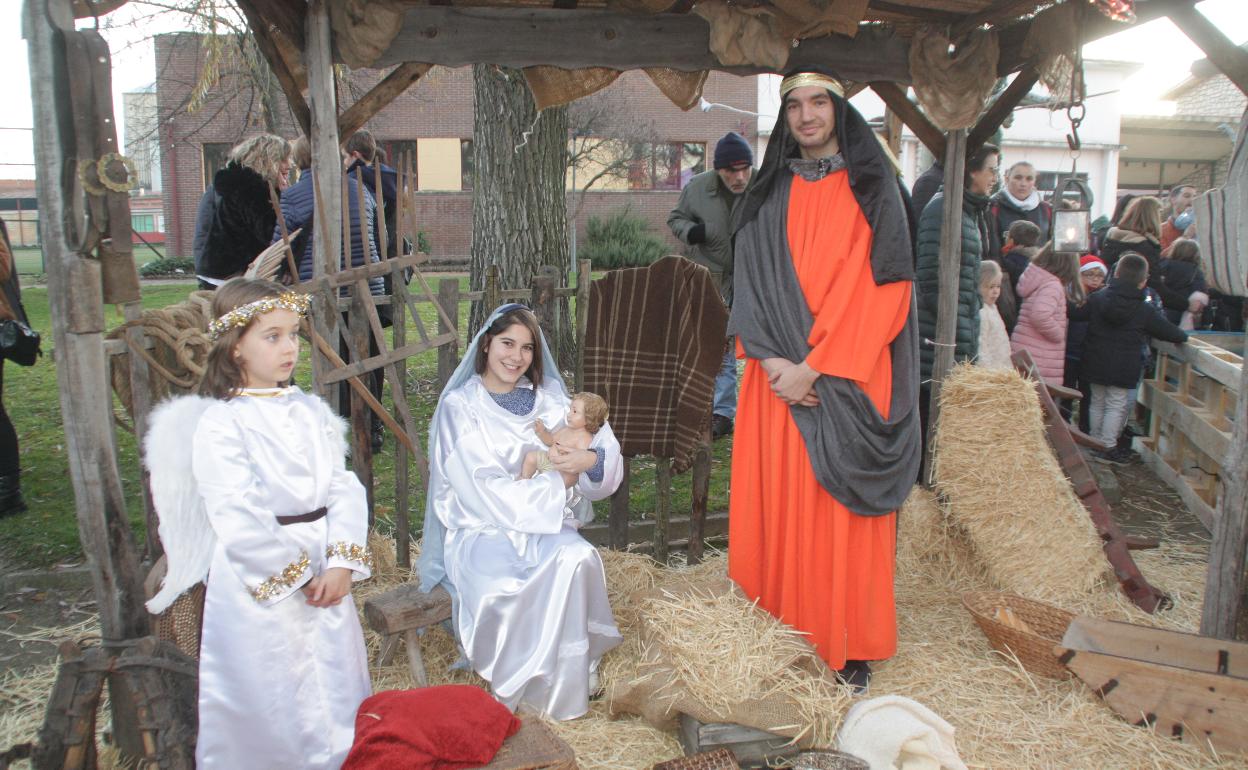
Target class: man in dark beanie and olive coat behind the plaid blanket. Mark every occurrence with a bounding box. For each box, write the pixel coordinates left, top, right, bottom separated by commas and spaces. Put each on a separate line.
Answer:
668, 131, 754, 438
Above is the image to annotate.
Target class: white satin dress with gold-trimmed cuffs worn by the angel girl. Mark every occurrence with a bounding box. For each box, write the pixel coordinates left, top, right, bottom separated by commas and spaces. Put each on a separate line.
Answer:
187, 388, 371, 770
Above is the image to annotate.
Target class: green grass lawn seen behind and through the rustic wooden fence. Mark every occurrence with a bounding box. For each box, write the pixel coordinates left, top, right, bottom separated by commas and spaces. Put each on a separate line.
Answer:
0, 277, 731, 568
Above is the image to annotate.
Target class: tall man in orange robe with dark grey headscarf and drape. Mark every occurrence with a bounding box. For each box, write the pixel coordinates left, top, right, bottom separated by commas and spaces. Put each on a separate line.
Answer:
728, 70, 920, 690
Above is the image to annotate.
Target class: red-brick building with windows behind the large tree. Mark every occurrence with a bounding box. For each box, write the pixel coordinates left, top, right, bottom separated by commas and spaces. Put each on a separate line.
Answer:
156, 32, 758, 260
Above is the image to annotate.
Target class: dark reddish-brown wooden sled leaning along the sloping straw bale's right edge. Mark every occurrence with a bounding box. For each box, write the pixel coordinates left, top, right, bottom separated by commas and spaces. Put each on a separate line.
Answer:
1012, 351, 1173, 613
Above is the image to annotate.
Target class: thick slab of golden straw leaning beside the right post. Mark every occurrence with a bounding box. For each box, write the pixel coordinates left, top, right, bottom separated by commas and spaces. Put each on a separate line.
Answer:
934, 364, 1109, 604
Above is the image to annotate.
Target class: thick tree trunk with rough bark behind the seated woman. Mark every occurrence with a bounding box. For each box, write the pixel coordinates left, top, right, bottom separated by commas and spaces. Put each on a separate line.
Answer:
468, 64, 575, 368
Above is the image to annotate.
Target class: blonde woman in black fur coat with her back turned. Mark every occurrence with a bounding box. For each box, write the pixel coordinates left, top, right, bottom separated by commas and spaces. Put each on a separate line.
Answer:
191, 134, 291, 288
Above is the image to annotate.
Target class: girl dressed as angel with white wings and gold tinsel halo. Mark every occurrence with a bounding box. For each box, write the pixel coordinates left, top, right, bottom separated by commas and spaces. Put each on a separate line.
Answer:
146, 278, 372, 770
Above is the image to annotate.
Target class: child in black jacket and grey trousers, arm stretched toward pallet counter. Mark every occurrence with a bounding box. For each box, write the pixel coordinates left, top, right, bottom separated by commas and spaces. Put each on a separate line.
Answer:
1082, 252, 1187, 465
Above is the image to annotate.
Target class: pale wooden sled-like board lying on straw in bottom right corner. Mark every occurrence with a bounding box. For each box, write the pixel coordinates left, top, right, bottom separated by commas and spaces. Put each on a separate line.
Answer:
1053, 618, 1248, 751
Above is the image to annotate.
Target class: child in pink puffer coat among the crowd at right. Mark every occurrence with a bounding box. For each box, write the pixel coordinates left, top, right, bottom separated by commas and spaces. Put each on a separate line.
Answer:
1010, 245, 1080, 384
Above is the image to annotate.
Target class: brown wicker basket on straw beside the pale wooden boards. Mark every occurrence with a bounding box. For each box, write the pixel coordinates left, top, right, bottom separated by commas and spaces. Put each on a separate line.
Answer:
962, 592, 1075, 679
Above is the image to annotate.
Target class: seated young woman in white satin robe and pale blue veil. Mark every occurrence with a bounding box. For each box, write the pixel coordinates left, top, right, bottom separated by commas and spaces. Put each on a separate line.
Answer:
418, 305, 622, 719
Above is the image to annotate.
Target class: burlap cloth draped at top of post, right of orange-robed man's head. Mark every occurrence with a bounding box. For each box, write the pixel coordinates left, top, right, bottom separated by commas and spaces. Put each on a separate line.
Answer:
910, 26, 998, 131
